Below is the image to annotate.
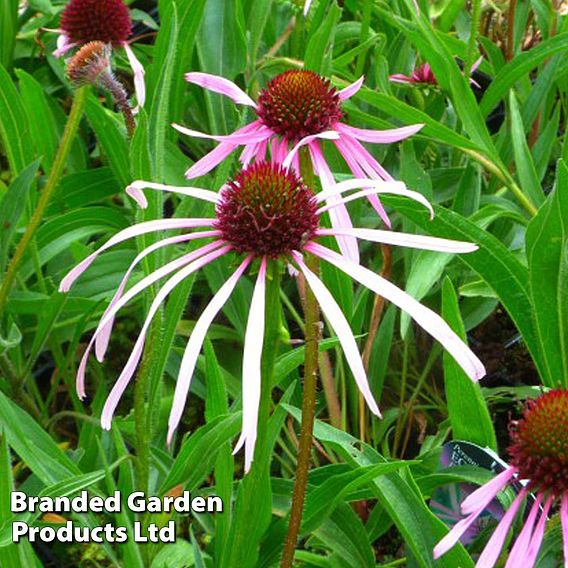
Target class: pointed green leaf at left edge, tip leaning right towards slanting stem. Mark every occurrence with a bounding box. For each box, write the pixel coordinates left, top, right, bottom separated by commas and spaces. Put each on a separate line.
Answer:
0, 160, 39, 272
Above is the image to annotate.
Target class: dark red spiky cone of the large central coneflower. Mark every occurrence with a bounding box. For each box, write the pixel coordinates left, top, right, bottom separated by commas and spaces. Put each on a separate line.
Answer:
216, 162, 318, 258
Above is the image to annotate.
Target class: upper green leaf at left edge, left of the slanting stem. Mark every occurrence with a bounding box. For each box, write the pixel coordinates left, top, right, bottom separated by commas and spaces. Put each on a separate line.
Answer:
0, 65, 35, 175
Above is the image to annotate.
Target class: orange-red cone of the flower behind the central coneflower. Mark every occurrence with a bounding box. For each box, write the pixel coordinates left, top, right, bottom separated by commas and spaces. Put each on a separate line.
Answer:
257, 70, 343, 142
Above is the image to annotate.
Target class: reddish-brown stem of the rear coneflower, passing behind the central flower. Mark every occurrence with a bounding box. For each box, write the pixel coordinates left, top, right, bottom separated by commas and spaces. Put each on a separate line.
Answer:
280, 147, 321, 568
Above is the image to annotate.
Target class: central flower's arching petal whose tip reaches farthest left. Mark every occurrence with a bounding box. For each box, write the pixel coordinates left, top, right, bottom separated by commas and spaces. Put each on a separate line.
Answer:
59, 218, 214, 292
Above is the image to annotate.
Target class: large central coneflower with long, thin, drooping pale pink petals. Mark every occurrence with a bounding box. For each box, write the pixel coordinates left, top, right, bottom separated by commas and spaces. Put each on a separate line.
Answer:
60, 162, 485, 470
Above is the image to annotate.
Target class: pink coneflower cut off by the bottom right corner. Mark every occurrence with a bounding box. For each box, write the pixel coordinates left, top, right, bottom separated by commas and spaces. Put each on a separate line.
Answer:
434, 389, 568, 568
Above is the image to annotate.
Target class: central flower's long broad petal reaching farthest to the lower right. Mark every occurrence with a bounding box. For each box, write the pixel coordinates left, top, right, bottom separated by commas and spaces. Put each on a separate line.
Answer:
306, 242, 485, 380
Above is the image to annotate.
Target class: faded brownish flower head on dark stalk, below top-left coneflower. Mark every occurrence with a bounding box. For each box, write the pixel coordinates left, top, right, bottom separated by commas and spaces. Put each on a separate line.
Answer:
67, 41, 136, 136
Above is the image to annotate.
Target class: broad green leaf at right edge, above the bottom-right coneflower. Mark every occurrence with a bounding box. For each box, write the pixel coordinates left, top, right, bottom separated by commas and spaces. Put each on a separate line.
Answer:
526, 161, 568, 387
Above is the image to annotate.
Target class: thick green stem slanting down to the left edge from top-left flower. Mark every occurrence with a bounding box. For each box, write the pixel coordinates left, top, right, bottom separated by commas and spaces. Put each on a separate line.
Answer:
0, 87, 87, 313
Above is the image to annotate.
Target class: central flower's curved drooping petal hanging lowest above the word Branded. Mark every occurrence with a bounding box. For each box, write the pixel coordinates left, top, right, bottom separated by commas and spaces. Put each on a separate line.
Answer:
101, 247, 230, 430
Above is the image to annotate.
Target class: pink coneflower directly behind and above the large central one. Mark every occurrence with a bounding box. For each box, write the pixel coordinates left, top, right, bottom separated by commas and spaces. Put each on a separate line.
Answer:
174, 70, 424, 260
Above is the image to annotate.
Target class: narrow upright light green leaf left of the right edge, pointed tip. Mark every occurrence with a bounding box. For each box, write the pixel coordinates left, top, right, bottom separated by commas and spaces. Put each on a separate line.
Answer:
509, 91, 544, 206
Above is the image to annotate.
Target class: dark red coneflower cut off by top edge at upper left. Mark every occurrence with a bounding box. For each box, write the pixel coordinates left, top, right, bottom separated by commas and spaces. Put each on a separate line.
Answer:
54, 0, 146, 107
